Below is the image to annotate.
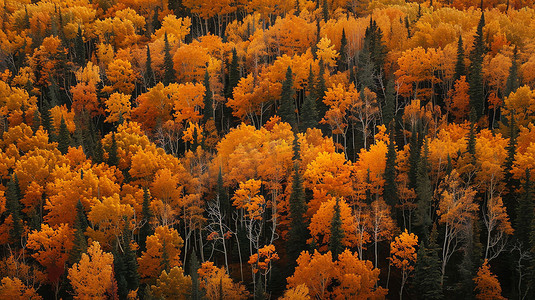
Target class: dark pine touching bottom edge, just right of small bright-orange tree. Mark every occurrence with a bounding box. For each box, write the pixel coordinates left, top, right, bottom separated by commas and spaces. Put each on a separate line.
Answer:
414, 226, 444, 300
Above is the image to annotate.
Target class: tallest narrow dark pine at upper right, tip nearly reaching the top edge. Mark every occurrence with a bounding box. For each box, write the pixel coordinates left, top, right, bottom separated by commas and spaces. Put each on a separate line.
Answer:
468, 12, 485, 119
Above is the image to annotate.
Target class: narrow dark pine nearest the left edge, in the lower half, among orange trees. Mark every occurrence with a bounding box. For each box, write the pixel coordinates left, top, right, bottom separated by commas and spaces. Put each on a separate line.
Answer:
5, 174, 23, 248
